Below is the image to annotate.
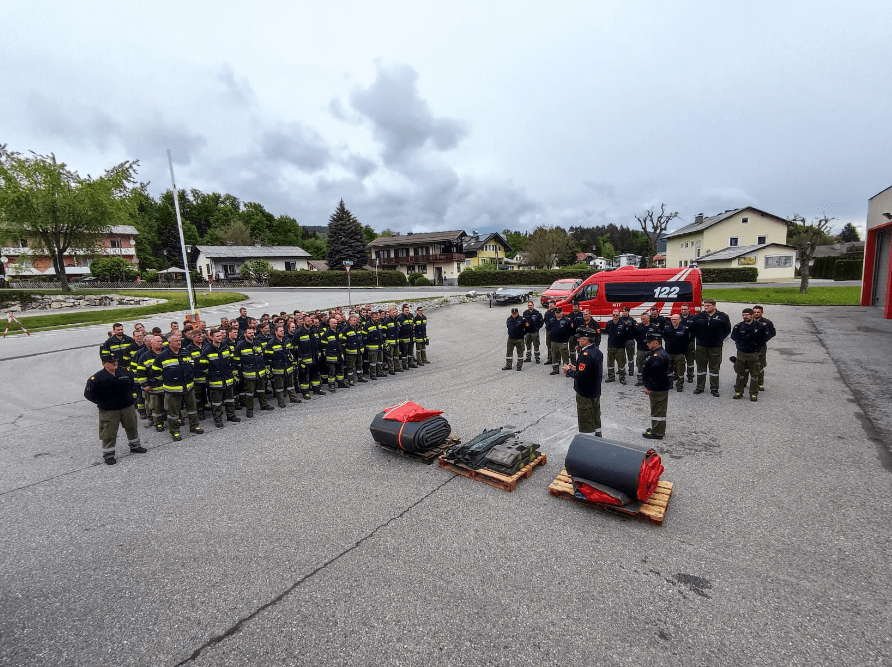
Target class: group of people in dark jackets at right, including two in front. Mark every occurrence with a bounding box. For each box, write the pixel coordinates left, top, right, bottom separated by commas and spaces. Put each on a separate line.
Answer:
503, 299, 776, 439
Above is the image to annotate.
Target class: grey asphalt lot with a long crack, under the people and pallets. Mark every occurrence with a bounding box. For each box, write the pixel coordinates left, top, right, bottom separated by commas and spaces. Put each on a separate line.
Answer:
0, 303, 892, 667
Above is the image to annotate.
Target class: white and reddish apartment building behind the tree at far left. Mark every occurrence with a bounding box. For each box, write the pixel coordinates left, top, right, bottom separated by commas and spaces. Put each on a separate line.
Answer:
0, 225, 139, 278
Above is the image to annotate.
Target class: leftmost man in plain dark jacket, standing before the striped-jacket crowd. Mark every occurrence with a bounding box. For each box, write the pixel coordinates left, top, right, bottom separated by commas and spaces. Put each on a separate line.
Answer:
84, 350, 146, 465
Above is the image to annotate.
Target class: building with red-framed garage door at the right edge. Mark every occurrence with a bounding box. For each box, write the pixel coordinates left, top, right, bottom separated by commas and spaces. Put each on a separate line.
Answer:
861, 186, 892, 319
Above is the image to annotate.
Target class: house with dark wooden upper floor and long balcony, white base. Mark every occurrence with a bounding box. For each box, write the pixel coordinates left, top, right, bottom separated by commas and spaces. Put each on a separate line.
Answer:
367, 229, 468, 285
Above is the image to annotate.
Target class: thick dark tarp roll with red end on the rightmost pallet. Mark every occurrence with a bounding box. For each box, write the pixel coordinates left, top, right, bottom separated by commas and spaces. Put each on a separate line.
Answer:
565, 433, 663, 510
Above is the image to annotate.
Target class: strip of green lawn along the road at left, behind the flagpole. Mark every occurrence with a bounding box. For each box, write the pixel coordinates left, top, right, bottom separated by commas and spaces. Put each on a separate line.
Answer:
9, 290, 248, 335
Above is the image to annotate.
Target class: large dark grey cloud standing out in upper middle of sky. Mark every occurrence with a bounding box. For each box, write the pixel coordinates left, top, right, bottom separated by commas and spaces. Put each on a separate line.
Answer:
348, 64, 468, 165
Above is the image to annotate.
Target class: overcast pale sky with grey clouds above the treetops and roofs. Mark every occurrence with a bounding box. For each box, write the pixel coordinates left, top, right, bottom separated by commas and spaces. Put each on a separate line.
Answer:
0, 0, 892, 237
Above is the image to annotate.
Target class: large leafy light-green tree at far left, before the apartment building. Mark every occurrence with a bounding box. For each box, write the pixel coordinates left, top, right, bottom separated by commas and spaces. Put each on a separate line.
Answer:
0, 144, 139, 292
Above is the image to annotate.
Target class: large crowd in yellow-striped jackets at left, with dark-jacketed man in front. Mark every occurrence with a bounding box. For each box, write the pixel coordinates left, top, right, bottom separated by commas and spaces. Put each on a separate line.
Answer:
84, 304, 430, 465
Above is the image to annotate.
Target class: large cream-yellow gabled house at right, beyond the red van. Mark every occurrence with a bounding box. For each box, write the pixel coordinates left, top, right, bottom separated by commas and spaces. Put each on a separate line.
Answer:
664, 206, 795, 281
